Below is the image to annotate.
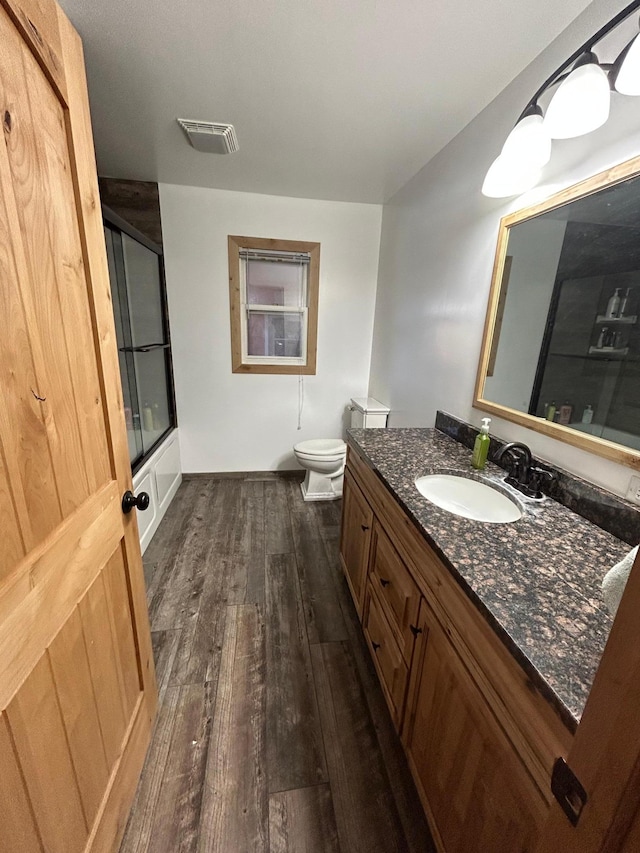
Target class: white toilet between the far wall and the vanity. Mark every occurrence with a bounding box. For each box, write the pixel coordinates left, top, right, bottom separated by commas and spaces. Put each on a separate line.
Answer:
293, 397, 389, 501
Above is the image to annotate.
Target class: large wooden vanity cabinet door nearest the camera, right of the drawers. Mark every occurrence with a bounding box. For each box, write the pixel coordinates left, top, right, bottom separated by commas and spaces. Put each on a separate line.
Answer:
403, 602, 547, 853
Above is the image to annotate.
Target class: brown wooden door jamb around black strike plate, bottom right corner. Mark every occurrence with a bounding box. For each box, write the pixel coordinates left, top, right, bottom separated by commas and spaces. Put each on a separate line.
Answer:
537, 555, 640, 853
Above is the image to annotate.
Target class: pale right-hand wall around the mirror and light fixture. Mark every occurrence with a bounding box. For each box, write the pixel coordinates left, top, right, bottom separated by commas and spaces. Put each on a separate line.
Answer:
369, 0, 640, 494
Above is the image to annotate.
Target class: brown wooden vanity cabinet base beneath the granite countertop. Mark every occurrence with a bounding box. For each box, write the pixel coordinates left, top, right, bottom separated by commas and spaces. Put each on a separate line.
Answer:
340, 446, 573, 853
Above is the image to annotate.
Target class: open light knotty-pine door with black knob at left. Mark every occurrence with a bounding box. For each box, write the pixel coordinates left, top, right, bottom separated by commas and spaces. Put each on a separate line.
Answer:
0, 0, 156, 853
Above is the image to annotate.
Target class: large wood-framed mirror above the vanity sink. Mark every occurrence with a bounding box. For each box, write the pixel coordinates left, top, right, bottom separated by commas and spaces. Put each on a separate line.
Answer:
474, 157, 640, 469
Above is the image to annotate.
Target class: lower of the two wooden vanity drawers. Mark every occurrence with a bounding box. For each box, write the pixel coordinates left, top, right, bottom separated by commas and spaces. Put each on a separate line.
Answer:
364, 585, 408, 728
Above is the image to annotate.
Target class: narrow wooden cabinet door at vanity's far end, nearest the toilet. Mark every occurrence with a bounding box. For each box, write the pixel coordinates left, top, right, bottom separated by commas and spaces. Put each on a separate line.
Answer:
340, 468, 373, 618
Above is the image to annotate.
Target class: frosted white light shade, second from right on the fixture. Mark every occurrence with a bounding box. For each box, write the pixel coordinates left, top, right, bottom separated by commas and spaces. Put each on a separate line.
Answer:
544, 60, 611, 139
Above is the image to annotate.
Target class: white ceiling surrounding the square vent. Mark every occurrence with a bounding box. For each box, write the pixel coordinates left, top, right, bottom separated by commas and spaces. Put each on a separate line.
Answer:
60, 0, 589, 203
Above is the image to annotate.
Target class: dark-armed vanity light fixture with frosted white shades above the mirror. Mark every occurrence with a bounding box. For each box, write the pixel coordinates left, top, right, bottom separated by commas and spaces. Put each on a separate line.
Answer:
482, 0, 640, 198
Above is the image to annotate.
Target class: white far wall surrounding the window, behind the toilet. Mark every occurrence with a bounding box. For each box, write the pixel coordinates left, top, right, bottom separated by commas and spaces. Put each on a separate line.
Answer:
160, 184, 382, 472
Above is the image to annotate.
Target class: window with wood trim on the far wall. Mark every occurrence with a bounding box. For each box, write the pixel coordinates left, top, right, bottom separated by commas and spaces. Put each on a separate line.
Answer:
229, 236, 320, 375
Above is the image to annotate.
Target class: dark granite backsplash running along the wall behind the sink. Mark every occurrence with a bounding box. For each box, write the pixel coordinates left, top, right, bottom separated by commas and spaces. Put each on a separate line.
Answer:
435, 411, 640, 545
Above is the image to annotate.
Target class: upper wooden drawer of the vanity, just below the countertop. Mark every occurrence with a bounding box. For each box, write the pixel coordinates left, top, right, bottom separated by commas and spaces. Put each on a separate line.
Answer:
369, 523, 420, 665
